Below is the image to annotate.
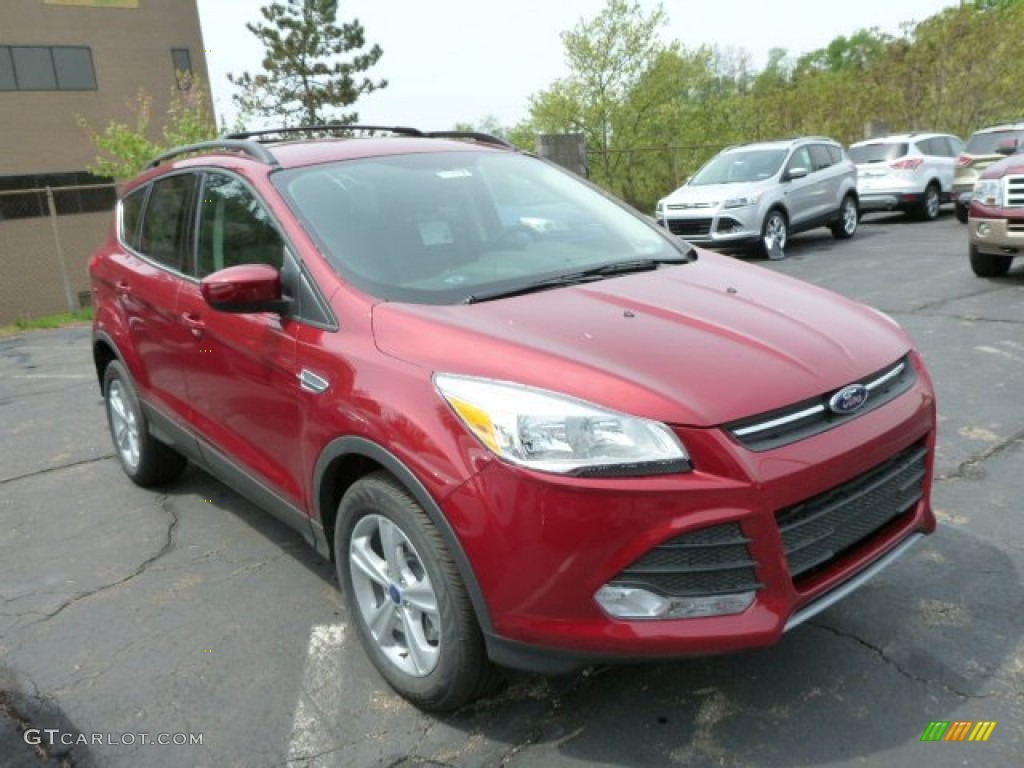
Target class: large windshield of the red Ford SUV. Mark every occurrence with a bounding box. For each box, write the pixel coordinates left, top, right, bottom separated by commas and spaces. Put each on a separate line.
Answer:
273, 152, 689, 304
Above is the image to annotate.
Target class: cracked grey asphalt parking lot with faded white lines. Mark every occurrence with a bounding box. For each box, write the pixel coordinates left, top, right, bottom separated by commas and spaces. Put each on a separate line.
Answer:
0, 213, 1024, 768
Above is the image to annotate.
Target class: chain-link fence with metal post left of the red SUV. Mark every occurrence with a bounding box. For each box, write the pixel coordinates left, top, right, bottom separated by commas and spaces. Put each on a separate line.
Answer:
0, 184, 117, 325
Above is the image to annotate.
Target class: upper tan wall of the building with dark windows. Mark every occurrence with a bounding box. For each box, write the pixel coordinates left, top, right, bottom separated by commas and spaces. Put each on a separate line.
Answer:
0, 0, 209, 176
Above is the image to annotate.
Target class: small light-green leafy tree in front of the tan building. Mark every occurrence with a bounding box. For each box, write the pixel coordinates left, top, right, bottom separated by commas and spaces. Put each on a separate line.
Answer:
78, 73, 217, 179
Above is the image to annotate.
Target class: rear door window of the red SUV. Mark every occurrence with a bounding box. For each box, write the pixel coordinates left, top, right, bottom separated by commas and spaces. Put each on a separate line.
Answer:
138, 173, 196, 273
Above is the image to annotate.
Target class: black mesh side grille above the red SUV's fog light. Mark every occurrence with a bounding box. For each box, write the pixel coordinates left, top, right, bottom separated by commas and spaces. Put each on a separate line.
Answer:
611, 522, 761, 597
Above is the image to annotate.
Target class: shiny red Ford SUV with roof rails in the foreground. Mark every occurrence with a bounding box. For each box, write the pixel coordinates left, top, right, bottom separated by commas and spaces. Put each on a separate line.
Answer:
90, 128, 935, 710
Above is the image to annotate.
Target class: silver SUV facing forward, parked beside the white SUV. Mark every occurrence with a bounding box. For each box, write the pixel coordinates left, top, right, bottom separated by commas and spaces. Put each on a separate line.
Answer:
654, 136, 858, 255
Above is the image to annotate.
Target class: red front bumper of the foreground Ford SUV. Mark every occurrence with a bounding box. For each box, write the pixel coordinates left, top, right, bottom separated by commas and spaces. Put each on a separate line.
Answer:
444, 358, 935, 672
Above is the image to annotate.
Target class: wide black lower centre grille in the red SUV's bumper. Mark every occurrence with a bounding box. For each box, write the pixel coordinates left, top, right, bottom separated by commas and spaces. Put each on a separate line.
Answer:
775, 443, 928, 582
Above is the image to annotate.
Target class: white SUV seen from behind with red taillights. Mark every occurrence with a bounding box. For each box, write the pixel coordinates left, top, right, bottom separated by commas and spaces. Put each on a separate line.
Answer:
850, 132, 964, 221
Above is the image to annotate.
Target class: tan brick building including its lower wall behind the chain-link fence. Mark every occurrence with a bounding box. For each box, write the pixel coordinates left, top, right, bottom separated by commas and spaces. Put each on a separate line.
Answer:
0, 0, 211, 324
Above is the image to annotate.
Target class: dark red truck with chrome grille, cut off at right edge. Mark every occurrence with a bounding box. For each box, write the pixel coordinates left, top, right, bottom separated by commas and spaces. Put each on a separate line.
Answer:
967, 154, 1024, 278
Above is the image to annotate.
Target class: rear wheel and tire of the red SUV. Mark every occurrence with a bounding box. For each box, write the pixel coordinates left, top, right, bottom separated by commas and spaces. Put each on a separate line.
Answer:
103, 360, 187, 487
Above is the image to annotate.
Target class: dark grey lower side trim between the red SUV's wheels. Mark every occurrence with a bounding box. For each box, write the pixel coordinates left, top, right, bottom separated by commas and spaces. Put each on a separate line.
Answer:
142, 402, 315, 547
